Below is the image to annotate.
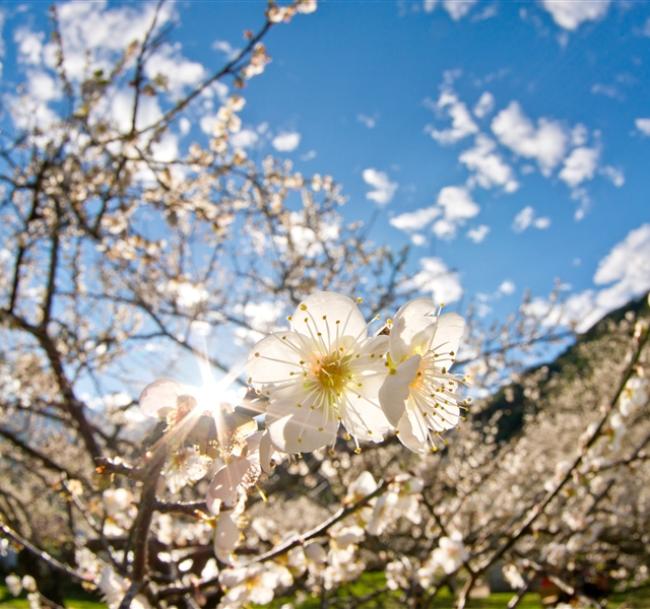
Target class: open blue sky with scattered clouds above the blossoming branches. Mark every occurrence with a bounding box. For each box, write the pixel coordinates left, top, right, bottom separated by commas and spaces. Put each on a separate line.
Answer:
0, 0, 650, 332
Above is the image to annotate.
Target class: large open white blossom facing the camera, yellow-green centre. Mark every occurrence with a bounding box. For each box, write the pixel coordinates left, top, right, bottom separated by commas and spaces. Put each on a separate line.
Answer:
247, 292, 391, 453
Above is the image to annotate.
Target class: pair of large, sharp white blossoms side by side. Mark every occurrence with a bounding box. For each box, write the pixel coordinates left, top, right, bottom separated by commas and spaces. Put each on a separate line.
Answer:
247, 292, 465, 454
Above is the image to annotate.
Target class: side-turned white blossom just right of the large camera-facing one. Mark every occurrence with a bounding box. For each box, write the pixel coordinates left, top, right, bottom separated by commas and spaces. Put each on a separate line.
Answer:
379, 298, 465, 453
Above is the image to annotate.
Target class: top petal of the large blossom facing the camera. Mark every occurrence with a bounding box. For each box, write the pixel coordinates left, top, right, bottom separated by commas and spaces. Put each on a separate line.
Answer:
291, 292, 368, 349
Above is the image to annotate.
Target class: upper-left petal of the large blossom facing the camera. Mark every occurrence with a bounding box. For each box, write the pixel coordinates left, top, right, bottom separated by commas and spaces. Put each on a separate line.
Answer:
246, 332, 303, 387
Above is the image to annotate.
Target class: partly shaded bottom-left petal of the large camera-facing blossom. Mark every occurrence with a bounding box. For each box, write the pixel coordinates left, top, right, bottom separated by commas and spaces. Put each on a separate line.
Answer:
269, 406, 339, 453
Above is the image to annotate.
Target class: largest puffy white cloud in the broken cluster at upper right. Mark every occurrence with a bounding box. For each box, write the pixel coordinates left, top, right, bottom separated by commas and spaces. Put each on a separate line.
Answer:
492, 102, 568, 175
